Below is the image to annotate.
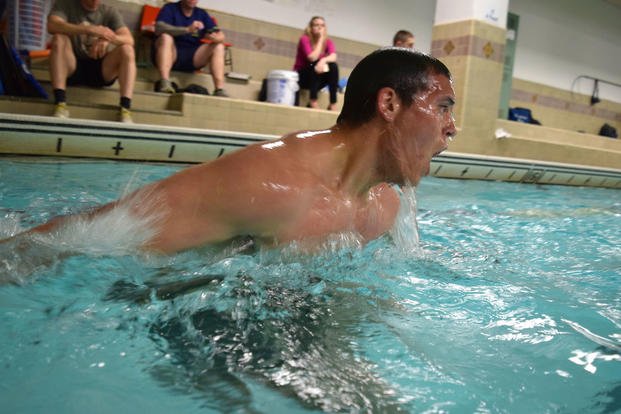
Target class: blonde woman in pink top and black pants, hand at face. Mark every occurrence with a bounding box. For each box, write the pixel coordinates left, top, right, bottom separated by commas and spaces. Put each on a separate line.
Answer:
293, 16, 339, 111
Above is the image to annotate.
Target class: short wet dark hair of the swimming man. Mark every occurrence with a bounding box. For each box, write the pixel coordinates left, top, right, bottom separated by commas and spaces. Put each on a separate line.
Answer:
337, 47, 451, 126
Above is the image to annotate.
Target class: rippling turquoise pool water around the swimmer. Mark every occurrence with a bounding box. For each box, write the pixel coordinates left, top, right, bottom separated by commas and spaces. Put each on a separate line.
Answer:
0, 159, 621, 413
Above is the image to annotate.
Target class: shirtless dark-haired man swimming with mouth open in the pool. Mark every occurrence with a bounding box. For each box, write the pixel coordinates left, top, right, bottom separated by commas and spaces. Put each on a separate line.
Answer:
0, 48, 456, 262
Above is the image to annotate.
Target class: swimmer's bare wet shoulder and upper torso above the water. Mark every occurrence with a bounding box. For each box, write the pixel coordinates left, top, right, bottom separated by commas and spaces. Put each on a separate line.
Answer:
137, 131, 399, 252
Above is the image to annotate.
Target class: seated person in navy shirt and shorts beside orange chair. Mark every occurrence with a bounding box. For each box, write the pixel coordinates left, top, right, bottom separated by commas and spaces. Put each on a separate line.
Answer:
153, 0, 228, 97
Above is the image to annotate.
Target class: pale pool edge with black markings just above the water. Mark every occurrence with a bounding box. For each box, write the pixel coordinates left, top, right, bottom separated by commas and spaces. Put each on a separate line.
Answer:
0, 113, 621, 189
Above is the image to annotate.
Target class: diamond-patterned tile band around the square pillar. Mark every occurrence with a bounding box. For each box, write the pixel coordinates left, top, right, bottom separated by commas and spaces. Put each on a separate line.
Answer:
431, 35, 505, 63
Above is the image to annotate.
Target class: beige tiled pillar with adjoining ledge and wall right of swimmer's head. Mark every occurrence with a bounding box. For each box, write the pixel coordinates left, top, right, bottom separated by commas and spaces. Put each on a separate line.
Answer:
432, 17, 621, 168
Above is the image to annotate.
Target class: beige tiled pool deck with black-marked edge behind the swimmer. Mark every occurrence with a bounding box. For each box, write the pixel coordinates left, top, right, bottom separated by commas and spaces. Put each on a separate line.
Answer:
0, 64, 621, 188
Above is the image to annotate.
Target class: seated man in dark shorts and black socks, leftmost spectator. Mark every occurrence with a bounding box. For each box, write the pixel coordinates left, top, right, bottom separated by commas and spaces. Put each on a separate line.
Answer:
47, 0, 136, 122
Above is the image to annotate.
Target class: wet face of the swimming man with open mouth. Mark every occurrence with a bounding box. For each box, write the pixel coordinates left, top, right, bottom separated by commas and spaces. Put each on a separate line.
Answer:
392, 73, 456, 185
